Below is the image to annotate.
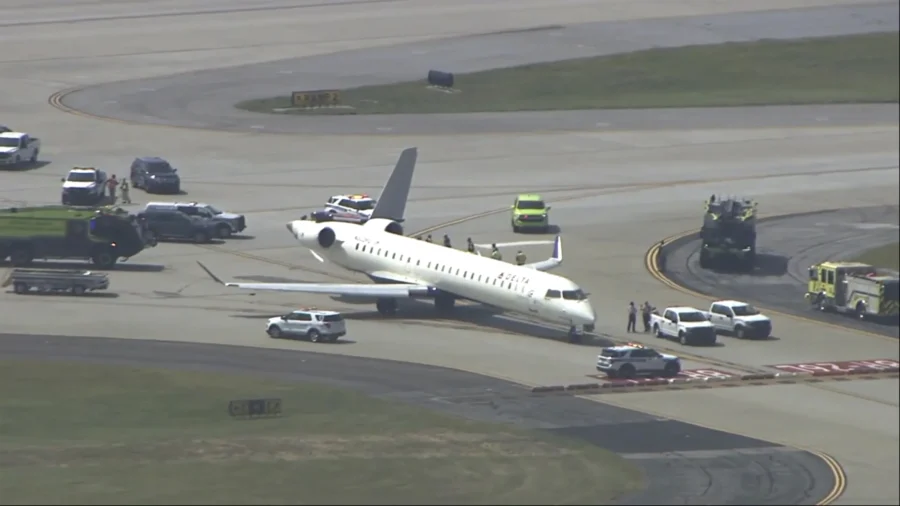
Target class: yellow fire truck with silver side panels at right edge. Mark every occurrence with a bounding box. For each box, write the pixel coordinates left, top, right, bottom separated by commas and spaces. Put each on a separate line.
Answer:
806, 262, 900, 318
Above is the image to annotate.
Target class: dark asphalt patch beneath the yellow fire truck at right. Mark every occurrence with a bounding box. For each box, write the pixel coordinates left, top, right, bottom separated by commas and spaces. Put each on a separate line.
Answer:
665, 206, 900, 338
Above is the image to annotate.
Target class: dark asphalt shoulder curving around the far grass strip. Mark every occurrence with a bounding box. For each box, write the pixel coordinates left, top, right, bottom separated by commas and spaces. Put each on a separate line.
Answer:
58, 2, 900, 135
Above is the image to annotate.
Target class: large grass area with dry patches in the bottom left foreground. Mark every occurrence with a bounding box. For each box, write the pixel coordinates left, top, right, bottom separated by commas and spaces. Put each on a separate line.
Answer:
0, 361, 641, 504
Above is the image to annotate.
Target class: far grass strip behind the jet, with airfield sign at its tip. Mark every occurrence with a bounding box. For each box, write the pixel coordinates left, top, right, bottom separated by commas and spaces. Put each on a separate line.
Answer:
237, 33, 900, 114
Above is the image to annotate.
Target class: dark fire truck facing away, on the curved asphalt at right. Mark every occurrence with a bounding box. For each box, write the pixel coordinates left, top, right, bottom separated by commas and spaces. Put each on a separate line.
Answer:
700, 195, 757, 271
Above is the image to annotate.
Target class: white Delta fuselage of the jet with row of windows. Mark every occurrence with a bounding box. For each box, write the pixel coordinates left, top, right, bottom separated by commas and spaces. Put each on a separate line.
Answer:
288, 220, 596, 328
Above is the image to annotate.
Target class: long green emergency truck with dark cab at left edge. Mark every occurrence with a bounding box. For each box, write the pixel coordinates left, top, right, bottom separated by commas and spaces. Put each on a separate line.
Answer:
0, 206, 156, 269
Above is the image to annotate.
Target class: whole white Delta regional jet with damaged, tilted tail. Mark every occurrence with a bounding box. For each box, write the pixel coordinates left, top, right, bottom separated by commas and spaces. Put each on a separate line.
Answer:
198, 148, 596, 341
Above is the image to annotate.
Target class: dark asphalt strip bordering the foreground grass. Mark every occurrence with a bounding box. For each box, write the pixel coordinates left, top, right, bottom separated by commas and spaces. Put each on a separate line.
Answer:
0, 334, 834, 504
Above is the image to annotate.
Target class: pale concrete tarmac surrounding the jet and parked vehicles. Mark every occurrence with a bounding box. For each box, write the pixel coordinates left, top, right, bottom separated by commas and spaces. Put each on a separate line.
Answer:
0, 0, 900, 504
